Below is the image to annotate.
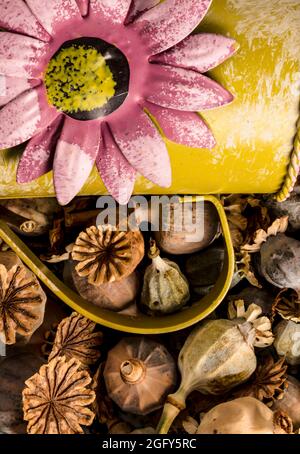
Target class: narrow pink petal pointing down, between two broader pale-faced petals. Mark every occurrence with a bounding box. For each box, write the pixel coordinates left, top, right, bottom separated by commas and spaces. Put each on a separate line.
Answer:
96, 123, 136, 205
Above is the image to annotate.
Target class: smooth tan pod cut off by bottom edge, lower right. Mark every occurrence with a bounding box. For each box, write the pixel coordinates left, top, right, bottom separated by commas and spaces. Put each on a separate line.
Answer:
196, 397, 293, 434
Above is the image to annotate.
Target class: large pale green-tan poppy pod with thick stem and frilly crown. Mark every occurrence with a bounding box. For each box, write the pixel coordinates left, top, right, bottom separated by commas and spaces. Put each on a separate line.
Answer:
157, 302, 273, 434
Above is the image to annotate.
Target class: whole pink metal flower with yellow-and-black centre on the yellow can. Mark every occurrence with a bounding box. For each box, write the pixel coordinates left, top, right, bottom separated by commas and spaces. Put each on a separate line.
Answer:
0, 0, 237, 205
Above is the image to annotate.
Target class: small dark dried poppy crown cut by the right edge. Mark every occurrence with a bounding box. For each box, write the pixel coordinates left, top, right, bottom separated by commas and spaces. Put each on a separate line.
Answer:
272, 289, 300, 323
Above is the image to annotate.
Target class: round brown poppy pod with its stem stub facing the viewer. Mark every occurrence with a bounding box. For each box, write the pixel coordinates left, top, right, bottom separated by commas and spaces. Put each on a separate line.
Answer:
104, 337, 176, 415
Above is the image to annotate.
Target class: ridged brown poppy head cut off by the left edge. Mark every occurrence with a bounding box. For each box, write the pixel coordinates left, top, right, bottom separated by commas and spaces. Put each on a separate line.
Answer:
0, 253, 47, 345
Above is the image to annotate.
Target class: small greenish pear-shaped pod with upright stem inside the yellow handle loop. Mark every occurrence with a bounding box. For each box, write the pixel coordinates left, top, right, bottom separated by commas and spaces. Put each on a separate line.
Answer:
141, 240, 190, 314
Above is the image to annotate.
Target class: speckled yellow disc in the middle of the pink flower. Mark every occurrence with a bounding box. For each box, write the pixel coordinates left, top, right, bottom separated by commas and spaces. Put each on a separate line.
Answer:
45, 45, 117, 114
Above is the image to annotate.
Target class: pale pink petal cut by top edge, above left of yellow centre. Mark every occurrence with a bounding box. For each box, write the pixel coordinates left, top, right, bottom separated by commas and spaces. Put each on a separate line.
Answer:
26, 0, 81, 36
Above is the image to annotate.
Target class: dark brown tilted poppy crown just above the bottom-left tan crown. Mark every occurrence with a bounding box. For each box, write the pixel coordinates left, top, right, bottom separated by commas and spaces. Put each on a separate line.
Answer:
49, 312, 103, 367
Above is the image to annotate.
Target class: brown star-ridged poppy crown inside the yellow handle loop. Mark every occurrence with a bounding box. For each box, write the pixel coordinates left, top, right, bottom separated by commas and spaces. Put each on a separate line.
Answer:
72, 225, 144, 285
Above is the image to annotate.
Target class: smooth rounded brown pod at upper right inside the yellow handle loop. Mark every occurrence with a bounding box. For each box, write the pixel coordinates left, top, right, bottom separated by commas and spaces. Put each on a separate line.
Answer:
154, 202, 220, 255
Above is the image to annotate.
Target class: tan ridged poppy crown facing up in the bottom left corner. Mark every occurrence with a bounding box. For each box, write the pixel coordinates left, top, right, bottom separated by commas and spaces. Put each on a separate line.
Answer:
23, 357, 95, 434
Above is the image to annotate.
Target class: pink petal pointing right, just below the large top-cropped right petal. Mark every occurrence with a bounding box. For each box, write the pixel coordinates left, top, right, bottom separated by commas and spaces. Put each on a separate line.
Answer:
151, 33, 238, 73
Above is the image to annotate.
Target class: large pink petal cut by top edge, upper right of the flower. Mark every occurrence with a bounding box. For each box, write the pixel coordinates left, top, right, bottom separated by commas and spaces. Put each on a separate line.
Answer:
135, 0, 212, 54
